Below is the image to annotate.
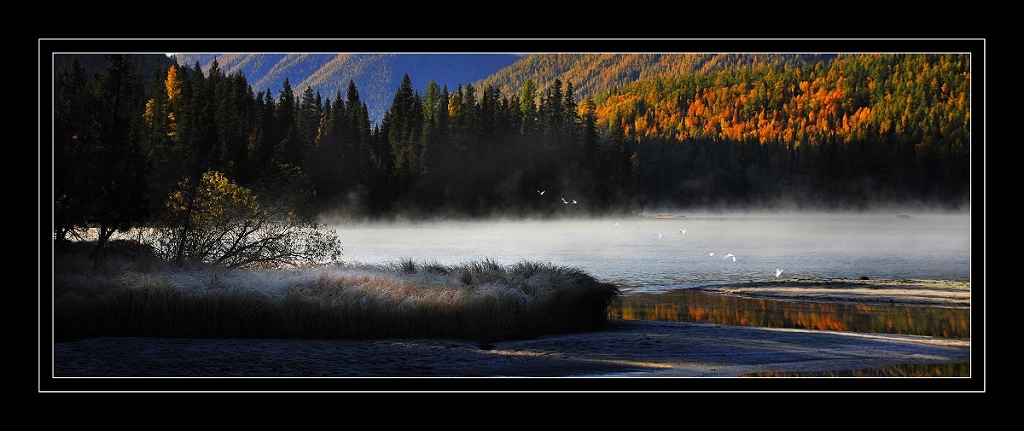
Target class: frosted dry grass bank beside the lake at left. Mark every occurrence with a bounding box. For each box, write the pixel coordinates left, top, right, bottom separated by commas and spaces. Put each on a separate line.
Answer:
53, 249, 620, 342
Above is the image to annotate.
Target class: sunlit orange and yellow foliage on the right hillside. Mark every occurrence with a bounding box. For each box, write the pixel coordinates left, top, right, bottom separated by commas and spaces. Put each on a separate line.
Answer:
597, 55, 968, 151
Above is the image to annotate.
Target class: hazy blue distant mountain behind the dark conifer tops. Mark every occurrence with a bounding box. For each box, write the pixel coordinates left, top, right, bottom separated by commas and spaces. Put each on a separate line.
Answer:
174, 52, 521, 123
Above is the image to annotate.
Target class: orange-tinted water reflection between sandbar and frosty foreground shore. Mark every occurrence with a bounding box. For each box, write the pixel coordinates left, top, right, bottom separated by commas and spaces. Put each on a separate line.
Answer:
611, 289, 971, 339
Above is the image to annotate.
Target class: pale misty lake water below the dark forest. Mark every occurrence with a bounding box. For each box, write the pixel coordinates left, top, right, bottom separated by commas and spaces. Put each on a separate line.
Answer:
329, 212, 971, 292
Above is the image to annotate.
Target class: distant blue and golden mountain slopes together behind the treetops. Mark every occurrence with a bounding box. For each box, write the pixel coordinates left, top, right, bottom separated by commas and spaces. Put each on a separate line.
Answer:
161, 53, 835, 128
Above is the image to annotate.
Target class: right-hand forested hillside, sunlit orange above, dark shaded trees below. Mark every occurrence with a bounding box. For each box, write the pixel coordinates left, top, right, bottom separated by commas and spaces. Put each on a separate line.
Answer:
597, 54, 972, 208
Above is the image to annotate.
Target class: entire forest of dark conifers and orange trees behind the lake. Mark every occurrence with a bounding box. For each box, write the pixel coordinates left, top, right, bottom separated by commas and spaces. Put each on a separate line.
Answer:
52, 53, 973, 253
